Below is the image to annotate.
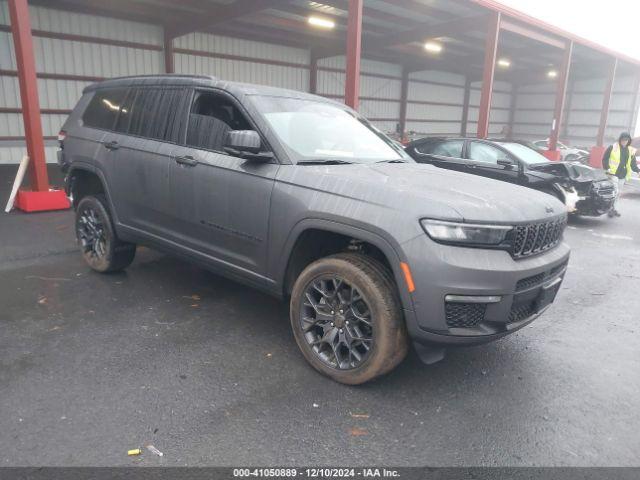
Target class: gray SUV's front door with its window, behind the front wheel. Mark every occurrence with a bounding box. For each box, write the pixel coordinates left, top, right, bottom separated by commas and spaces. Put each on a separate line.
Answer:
170, 91, 278, 275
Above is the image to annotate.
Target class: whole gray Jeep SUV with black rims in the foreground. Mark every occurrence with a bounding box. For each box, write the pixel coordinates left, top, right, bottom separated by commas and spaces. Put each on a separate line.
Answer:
58, 75, 569, 384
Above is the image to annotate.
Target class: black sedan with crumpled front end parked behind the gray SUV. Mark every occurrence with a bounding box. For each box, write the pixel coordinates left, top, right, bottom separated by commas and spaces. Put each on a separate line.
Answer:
406, 138, 615, 216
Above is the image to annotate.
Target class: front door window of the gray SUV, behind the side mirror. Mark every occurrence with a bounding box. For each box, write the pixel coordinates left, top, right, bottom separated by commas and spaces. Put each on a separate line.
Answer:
187, 92, 252, 152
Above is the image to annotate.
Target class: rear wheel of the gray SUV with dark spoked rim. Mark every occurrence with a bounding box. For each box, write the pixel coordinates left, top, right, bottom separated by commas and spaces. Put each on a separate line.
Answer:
76, 195, 136, 273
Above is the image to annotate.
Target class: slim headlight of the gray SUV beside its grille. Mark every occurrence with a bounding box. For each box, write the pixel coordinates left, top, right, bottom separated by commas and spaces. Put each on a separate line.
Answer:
420, 219, 513, 245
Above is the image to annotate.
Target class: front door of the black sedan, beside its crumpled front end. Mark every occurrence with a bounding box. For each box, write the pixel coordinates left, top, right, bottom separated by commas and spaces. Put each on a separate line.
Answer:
466, 140, 520, 183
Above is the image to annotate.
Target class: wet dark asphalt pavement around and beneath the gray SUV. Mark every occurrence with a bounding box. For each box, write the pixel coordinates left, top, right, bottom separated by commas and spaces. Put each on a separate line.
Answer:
0, 167, 640, 466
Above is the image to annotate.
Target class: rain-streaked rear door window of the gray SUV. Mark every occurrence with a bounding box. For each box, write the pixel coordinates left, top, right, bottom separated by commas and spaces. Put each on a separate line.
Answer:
115, 88, 187, 142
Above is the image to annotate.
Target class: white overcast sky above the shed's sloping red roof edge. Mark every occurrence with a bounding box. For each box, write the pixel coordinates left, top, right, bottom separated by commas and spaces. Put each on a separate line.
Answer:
498, 0, 640, 136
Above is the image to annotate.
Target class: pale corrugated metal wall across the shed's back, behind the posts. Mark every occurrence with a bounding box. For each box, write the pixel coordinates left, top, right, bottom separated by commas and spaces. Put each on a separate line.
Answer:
0, 0, 637, 163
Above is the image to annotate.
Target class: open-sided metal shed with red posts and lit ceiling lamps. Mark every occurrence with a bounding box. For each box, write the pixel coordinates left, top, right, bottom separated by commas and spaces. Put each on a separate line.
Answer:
0, 0, 640, 180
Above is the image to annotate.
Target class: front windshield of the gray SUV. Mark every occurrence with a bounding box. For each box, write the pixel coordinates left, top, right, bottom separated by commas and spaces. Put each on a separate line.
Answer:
254, 96, 411, 163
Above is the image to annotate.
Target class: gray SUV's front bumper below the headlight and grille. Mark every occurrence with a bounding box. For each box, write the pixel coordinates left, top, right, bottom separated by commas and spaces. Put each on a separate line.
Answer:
403, 236, 570, 363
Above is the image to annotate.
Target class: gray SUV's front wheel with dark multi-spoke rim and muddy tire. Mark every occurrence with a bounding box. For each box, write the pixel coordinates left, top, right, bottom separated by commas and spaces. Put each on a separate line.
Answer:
290, 253, 408, 385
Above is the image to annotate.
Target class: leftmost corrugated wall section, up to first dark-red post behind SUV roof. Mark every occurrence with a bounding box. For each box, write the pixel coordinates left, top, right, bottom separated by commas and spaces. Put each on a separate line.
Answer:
0, 1, 164, 163
